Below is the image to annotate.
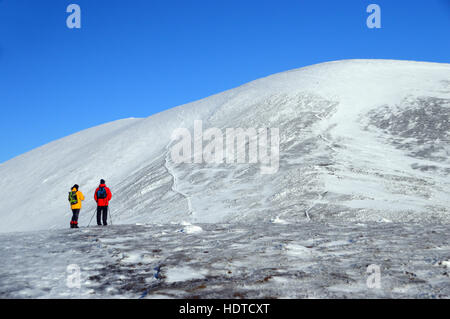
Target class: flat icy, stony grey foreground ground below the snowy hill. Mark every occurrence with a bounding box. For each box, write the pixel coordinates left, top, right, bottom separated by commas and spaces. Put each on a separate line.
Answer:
0, 219, 450, 298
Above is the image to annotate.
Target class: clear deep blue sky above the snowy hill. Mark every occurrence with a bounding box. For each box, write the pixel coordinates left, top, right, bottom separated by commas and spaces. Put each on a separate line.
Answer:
0, 0, 450, 162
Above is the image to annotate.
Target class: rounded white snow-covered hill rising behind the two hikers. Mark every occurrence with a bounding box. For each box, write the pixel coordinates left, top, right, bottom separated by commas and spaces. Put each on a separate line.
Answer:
0, 60, 450, 232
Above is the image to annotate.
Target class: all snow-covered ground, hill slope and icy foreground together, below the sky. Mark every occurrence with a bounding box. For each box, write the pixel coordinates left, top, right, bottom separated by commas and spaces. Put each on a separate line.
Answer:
0, 60, 450, 298
